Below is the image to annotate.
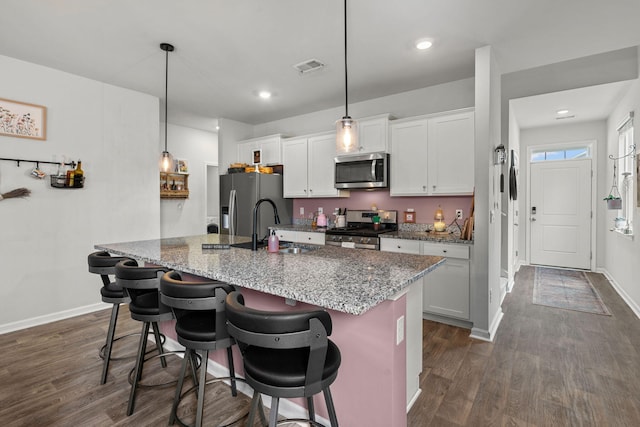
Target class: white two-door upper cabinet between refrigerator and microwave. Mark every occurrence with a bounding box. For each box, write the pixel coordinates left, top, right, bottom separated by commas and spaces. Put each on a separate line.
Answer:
282, 132, 349, 198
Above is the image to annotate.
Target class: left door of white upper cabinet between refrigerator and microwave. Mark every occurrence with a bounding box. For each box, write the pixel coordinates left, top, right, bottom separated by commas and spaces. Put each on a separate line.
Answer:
282, 138, 308, 197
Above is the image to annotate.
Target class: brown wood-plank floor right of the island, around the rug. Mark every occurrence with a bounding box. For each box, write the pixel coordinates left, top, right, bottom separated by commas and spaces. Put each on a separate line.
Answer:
409, 267, 640, 427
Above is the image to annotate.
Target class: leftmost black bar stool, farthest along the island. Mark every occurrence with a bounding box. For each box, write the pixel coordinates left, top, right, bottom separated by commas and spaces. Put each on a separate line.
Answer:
87, 251, 131, 384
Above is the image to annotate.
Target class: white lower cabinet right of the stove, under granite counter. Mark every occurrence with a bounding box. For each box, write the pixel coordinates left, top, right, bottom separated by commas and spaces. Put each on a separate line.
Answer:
380, 238, 470, 320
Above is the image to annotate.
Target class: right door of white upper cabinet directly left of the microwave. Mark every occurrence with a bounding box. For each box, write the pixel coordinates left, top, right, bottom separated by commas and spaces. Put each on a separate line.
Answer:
308, 132, 338, 197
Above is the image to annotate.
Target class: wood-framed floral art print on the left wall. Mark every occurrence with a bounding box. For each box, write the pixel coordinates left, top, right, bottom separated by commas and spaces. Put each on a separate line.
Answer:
0, 98, 47, 140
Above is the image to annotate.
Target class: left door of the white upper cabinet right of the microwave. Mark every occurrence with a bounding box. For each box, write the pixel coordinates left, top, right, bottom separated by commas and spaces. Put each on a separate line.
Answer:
389, 119, 428, 196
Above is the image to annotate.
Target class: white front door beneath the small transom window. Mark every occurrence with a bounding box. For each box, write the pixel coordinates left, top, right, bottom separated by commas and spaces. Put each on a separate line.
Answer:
529, 159, 591, 269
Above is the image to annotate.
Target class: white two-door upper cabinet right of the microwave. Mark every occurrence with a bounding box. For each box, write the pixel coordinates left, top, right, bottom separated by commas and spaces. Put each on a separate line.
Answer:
390, 110, 475, 196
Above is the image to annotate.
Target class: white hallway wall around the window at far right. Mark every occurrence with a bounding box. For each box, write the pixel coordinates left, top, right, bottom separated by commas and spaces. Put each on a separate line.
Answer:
600, 75, 640, 317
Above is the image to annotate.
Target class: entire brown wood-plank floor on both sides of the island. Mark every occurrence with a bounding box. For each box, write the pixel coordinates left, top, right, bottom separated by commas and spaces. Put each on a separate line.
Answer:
0, 267, 640, 427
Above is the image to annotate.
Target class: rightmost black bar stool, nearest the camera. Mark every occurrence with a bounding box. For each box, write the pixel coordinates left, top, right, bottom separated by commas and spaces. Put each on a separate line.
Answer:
226, 292, 341, 427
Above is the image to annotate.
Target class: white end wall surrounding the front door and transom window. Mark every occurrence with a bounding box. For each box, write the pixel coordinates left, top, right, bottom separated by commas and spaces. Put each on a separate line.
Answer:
518, 120, 613, 266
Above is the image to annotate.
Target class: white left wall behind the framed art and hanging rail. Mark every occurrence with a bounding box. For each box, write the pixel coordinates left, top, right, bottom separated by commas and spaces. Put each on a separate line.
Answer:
0, 56, 160, 333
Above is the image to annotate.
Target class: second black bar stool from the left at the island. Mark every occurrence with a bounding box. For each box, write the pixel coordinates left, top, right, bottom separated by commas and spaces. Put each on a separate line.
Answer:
116, 260, 173, 415
